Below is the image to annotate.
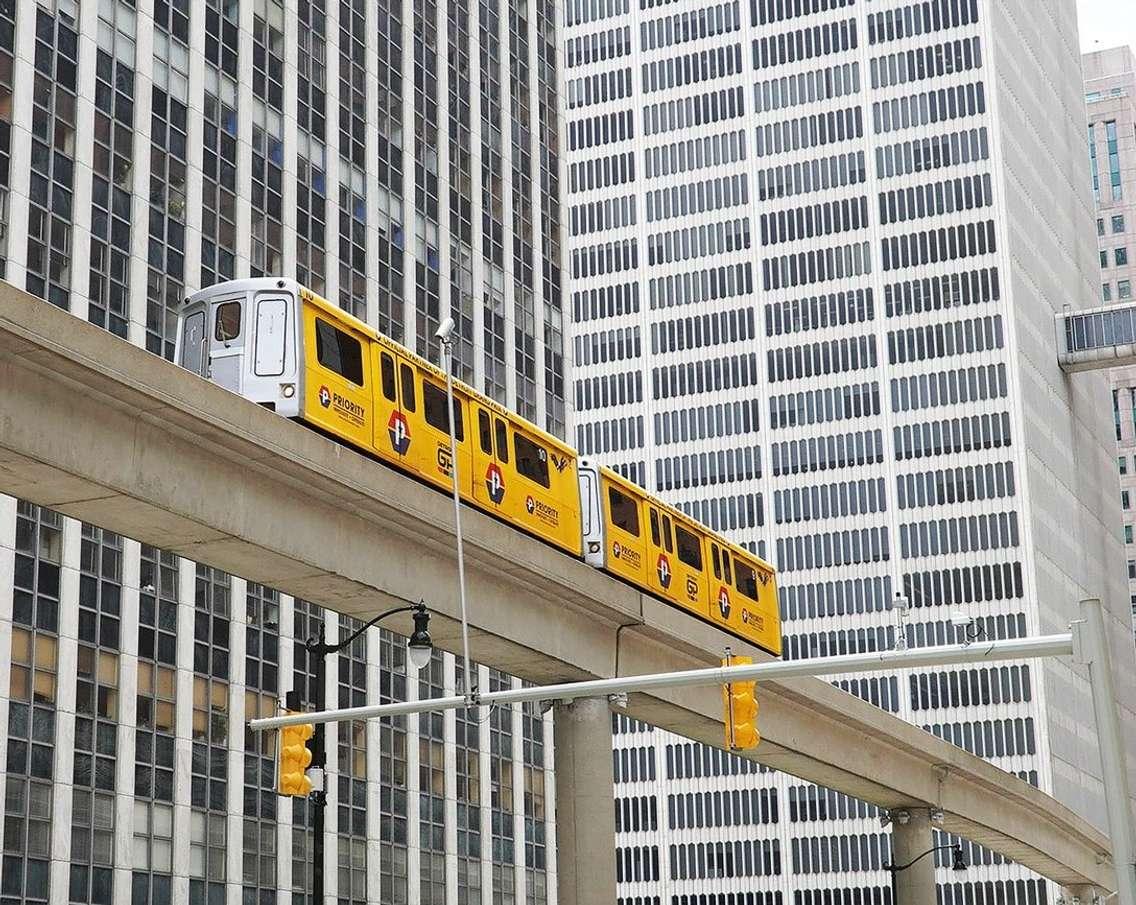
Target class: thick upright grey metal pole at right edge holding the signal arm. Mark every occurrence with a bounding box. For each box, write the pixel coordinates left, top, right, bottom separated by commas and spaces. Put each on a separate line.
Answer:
1078, 598, 1136, 905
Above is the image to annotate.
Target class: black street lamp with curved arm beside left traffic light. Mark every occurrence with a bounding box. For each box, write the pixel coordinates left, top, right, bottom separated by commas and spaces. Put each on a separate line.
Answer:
287, 603, 434, 905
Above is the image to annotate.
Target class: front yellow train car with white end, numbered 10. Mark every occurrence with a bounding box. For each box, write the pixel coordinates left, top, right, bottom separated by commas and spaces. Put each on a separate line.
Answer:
176, 278, 583, 556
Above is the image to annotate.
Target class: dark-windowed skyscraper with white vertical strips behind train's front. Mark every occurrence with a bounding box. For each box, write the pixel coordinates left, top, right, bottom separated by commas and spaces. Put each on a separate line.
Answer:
0, 0, 563, 905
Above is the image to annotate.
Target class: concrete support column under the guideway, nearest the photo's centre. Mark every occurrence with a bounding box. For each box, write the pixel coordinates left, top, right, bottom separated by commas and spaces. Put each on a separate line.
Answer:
552, 697, 616, 905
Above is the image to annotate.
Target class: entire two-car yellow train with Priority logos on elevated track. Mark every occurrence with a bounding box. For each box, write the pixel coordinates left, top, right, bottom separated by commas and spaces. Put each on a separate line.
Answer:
177, 278, 782, 655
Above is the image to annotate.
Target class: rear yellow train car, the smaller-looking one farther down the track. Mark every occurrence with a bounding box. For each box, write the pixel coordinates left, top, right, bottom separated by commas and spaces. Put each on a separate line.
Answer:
579, 458, 782, 656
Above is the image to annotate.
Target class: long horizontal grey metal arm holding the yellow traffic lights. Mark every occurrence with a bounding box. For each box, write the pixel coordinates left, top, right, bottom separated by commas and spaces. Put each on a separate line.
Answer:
249, 635, 1072, 731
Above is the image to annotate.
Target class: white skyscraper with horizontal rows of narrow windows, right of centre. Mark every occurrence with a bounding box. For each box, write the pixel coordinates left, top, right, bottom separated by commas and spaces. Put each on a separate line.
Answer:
565, 0, 1133, 905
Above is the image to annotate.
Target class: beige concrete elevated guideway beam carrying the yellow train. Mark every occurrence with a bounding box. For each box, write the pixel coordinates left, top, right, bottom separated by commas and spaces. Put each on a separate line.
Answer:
0, 283, 1116, 895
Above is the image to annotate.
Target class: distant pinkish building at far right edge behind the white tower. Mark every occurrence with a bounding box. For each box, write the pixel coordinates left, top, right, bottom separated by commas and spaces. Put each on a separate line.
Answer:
1084, 47, 1136, 635
